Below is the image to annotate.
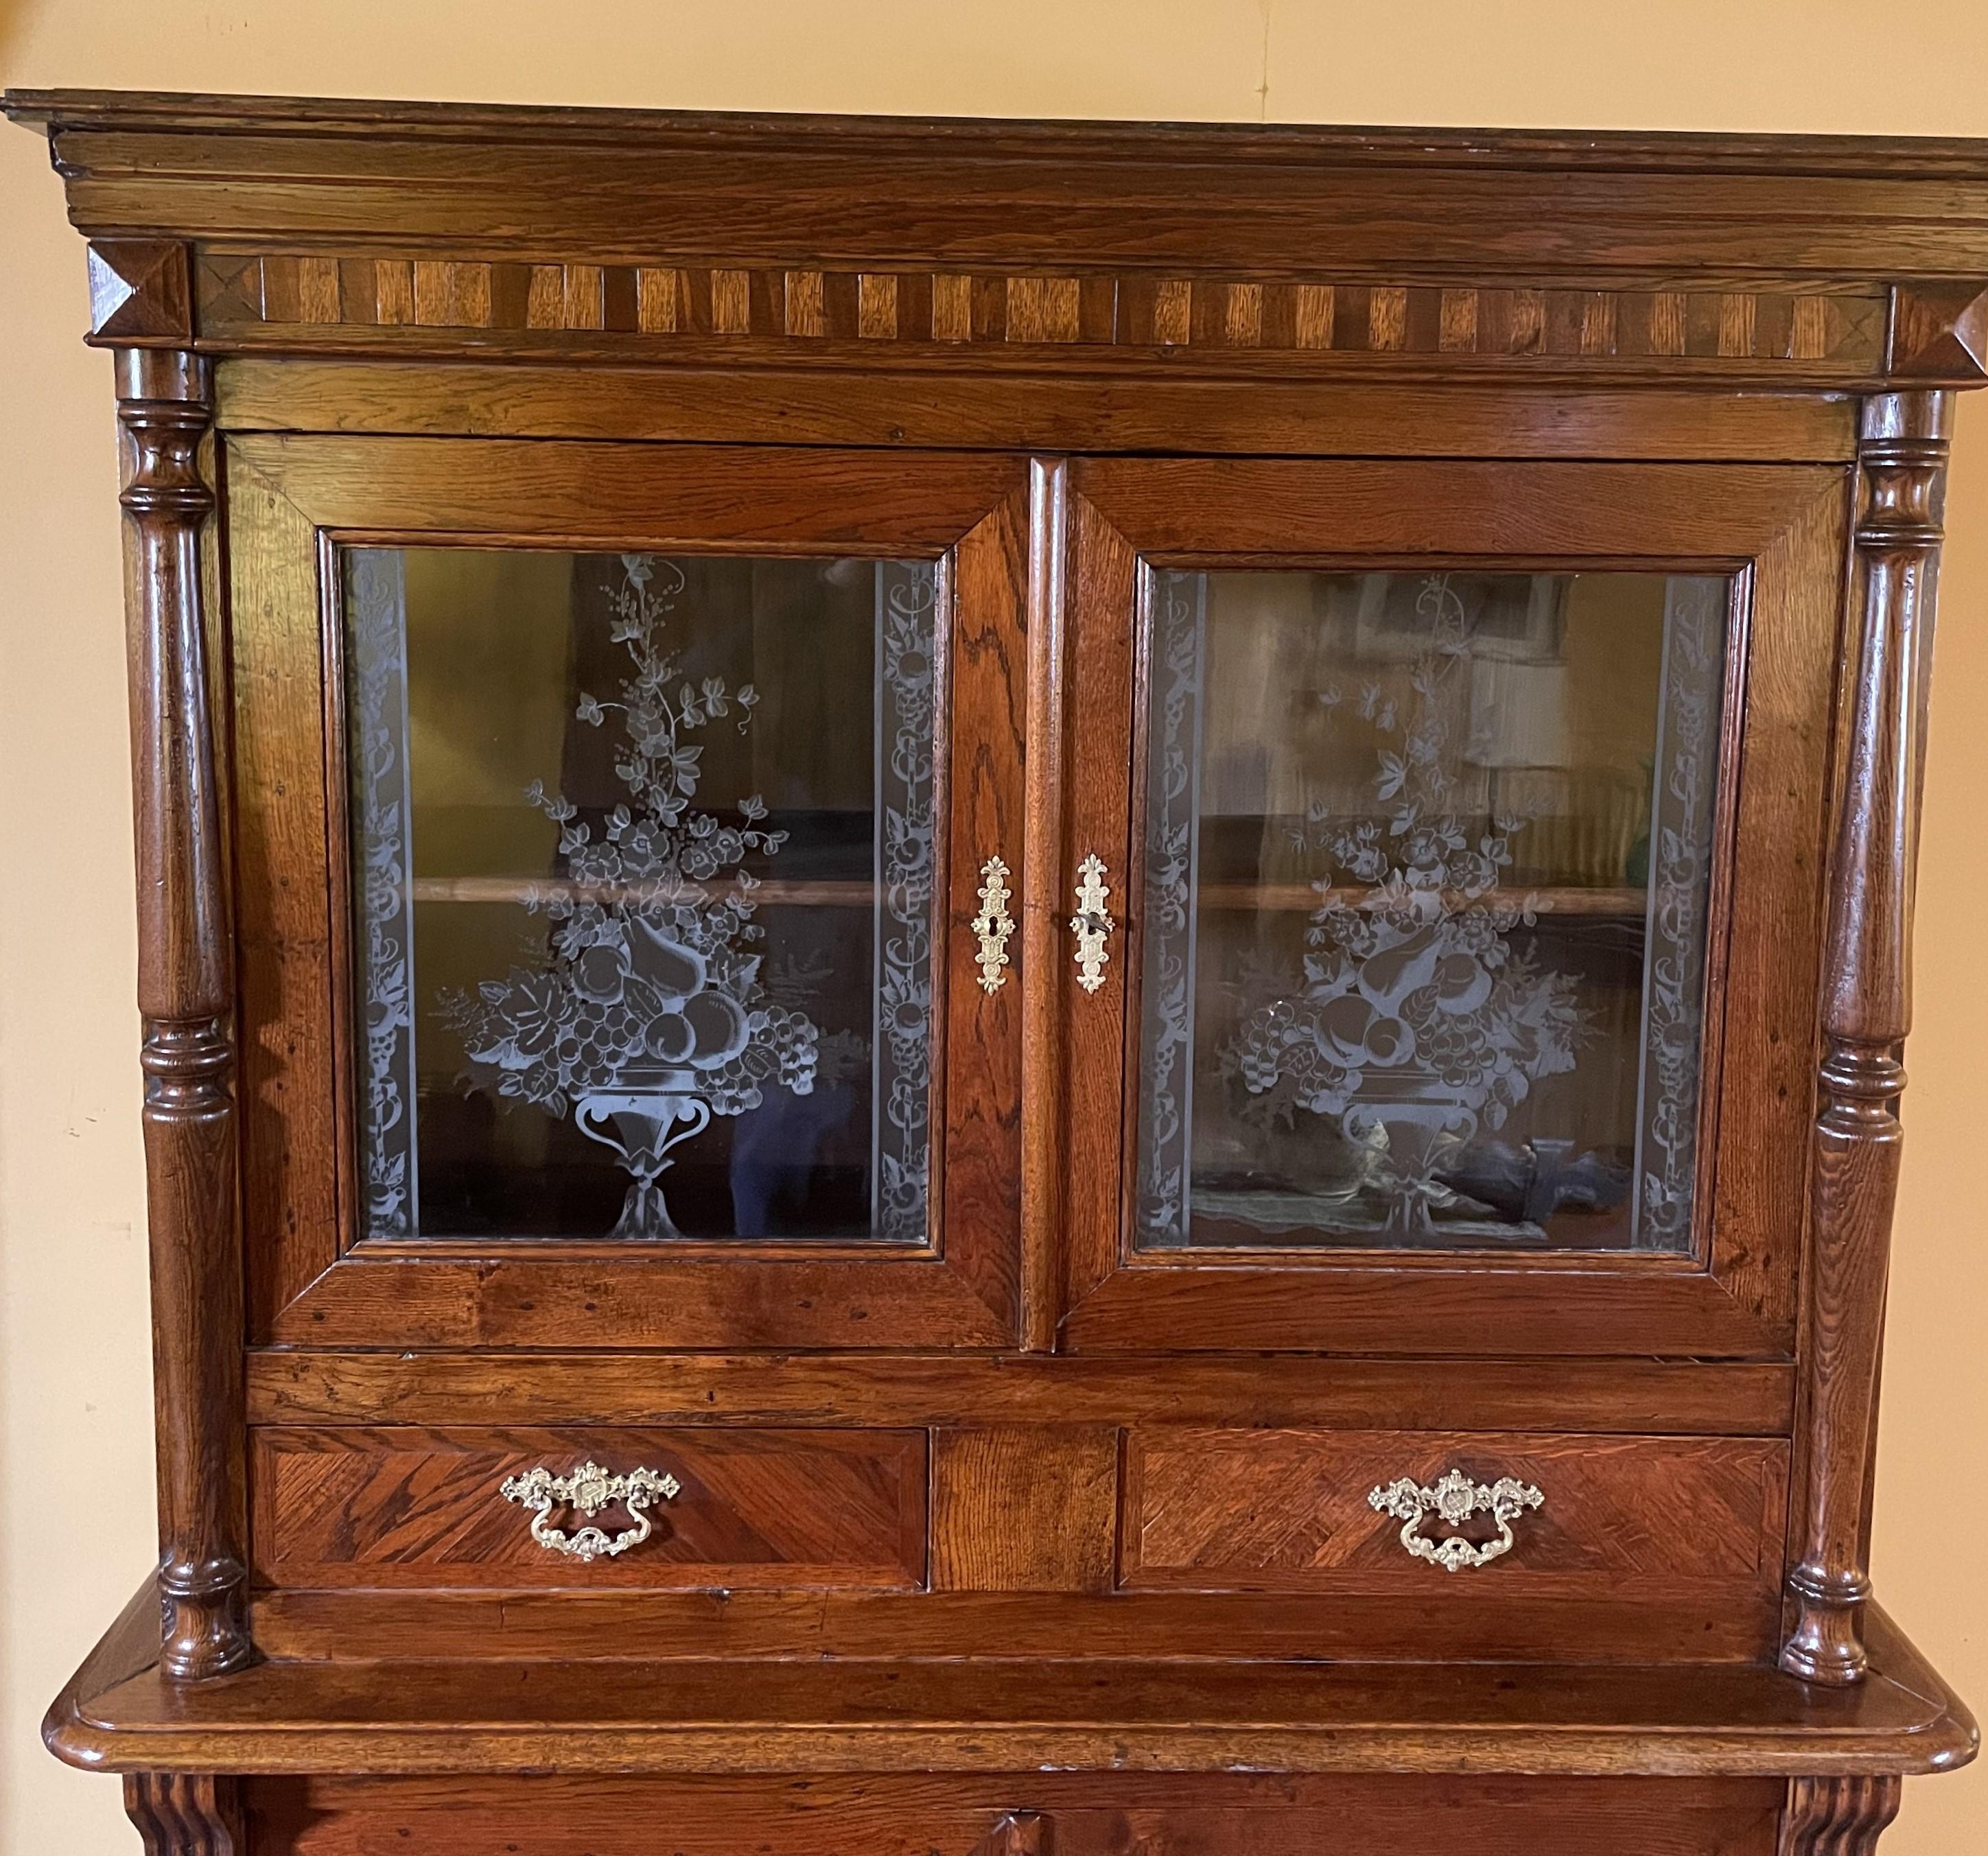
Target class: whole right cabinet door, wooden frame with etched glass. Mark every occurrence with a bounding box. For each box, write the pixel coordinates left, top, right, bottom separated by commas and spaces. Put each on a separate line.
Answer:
1066, 463, 1841, 1351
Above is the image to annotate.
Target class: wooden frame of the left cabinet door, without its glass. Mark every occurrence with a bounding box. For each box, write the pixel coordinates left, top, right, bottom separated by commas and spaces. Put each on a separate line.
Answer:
222, 433, 1030, 1349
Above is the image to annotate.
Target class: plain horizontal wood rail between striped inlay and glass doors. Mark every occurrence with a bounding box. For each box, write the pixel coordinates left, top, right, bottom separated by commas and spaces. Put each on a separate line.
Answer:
215, 355, 1857, 463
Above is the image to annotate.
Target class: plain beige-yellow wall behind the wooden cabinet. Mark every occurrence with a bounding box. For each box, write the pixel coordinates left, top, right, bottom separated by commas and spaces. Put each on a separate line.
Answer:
0, 0, 1988, 1856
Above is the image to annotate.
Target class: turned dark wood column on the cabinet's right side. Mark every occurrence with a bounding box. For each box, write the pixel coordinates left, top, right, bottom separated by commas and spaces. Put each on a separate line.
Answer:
1781, 392, 1952, 1687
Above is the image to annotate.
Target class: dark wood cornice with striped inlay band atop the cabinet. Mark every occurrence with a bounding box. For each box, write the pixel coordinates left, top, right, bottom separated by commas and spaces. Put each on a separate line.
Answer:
6, 91, 1988, 390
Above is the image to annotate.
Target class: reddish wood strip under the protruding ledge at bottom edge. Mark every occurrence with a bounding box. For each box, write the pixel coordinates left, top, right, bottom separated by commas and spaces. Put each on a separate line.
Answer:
244, 1772, 1789, 1856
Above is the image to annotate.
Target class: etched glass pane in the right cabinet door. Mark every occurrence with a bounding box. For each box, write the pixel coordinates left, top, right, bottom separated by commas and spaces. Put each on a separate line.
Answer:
1133, 570, 1731, 1252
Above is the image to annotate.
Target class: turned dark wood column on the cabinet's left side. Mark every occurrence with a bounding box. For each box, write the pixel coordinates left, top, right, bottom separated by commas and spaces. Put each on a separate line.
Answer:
117, 348, 253, 1677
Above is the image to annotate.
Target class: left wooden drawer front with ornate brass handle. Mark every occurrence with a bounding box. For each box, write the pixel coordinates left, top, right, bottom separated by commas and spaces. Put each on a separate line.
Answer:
248, 1426, 926, 1590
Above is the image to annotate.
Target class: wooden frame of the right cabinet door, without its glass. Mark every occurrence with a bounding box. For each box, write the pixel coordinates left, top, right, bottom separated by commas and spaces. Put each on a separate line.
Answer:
1057, 459, 1851, 1357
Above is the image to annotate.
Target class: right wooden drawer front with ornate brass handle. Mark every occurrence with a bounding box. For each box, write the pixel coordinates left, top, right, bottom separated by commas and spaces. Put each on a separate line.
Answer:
1119, 1429, 1787, 1606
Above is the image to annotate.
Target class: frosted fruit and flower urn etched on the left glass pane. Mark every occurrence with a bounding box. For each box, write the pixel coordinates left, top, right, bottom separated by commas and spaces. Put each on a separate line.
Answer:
445, 554, 821, 1238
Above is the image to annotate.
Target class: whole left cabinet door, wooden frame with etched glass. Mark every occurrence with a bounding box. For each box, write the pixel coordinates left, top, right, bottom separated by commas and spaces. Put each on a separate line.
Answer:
231, 437, 1028, 1346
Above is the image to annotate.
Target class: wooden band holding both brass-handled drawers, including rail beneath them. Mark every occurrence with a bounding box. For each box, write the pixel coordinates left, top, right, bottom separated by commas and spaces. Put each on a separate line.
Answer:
248, 1423, 1789, 1663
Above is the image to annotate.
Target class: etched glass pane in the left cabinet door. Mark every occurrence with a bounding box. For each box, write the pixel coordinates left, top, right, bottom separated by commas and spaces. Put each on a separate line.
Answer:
342, 548, 936, 1244
